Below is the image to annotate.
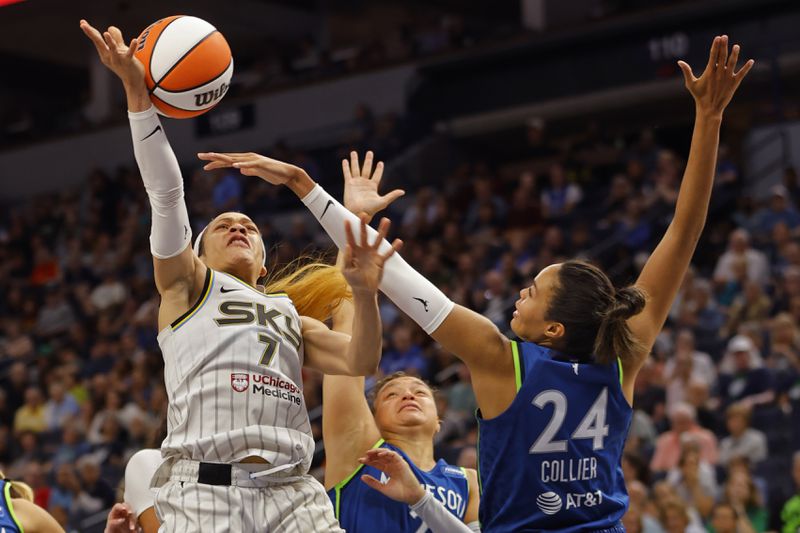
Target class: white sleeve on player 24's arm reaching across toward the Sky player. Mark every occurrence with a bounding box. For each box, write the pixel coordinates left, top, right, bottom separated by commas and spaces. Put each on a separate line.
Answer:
303, 185, 455, 334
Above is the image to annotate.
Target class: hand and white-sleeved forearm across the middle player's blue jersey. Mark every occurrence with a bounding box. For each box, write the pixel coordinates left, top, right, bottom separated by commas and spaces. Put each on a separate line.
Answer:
359, 448, 480, 533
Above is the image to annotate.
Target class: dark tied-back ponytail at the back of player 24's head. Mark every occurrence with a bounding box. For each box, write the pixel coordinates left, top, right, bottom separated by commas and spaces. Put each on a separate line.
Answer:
594, 287, 645, 364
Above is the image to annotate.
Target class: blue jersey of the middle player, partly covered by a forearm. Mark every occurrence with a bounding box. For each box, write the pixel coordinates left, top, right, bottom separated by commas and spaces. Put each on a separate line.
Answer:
328, 439, 469, 533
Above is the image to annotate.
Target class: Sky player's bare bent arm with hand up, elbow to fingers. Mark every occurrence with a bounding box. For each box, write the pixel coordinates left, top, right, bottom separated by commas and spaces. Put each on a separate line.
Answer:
302, 214, 402, 376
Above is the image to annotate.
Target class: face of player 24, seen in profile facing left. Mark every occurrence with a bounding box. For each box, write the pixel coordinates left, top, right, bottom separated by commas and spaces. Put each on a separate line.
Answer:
511, 264, 564, 342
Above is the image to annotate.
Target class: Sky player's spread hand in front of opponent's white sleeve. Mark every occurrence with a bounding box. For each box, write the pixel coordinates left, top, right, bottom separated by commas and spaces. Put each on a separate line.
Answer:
342, 215, 403, 292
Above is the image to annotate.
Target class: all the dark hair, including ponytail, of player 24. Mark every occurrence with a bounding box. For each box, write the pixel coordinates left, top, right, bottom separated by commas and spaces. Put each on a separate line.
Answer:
545, 261, 645, 364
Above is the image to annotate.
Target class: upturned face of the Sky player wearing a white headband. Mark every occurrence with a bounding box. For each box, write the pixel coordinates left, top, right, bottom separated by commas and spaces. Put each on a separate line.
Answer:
203, 212, 266, 278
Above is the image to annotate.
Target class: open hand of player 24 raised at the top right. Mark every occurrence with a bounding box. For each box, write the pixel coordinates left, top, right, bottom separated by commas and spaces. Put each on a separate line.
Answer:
678, 35, 755, 115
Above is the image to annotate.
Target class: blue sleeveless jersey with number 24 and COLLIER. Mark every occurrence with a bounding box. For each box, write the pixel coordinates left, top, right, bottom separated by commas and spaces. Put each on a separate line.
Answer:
478, 342, 632, 533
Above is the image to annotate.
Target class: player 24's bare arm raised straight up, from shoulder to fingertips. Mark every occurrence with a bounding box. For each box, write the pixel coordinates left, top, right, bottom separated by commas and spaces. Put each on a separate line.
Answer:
623, 36, 753, 380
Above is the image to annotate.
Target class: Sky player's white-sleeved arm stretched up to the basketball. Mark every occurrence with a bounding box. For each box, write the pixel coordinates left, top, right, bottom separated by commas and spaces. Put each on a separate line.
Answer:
80, 20, 205, 329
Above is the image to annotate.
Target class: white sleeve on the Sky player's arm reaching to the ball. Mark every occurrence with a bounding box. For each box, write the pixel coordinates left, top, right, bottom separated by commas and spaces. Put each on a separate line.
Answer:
128, 107, 192, 259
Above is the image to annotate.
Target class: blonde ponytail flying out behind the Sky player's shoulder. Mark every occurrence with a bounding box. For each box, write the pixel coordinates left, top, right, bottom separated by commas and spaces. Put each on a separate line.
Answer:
263, 255, 351, 322
